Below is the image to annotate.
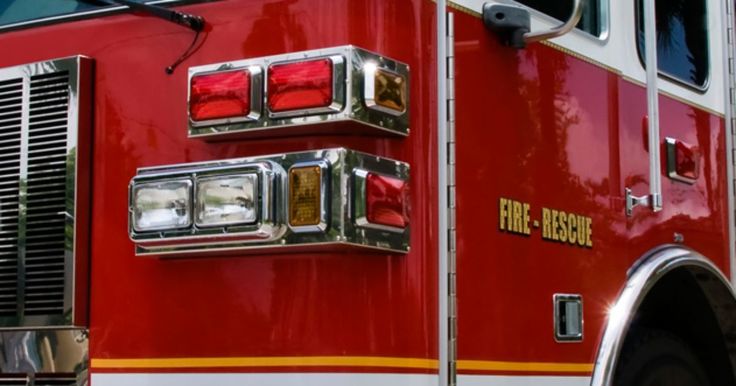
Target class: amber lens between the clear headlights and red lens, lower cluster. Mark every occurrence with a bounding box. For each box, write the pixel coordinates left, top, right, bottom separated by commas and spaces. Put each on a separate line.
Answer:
289, 166, 322, 226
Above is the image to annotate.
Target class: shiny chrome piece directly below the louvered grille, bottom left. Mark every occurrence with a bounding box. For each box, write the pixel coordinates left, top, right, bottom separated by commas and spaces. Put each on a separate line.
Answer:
0, 329, 89, 386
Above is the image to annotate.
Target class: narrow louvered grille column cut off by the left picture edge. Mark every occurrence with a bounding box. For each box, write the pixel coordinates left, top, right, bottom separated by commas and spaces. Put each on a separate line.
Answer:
0, 78, 23, 316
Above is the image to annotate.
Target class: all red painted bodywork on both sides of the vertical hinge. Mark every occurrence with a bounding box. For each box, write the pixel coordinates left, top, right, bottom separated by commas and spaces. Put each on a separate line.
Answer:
0, 0, 728, 380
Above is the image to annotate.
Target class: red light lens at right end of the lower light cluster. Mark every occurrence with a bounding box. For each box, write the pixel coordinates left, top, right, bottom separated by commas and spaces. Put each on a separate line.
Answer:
365, 173, 409, 228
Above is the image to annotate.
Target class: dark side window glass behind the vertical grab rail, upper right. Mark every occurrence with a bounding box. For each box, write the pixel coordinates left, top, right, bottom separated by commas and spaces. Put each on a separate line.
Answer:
636, 0, 708, 89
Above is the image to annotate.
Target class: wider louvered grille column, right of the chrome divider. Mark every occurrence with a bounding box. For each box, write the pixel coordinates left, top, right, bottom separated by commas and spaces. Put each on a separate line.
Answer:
23, 71, 69, 315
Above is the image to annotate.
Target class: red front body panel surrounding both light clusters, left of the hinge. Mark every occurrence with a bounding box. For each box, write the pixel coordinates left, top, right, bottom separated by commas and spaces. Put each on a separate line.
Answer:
0, 0, 437, 364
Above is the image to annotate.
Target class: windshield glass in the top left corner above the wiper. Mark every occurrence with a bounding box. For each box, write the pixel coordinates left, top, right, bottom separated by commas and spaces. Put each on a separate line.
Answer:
0, 0, 145, 26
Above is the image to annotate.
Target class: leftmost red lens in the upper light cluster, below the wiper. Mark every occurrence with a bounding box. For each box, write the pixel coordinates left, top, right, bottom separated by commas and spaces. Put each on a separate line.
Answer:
189, 70, 250, 121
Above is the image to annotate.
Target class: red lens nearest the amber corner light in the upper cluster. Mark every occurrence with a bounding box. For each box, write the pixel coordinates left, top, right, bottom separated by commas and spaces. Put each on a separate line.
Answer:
268, 58, 333, 112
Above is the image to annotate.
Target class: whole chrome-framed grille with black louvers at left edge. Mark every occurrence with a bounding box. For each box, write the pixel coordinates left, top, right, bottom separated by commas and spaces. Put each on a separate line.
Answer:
0, 57, 91, 328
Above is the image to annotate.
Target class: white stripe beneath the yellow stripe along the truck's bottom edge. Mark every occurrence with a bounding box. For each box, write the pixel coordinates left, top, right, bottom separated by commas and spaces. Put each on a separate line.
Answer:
92, 373, 590, 386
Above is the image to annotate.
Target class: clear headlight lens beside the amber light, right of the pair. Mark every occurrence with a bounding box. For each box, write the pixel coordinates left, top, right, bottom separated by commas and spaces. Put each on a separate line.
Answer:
197, 174, 258, 226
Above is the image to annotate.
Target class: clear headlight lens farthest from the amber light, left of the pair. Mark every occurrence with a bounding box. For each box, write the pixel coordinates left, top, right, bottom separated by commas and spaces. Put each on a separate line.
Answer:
132, 180, 192, 232
